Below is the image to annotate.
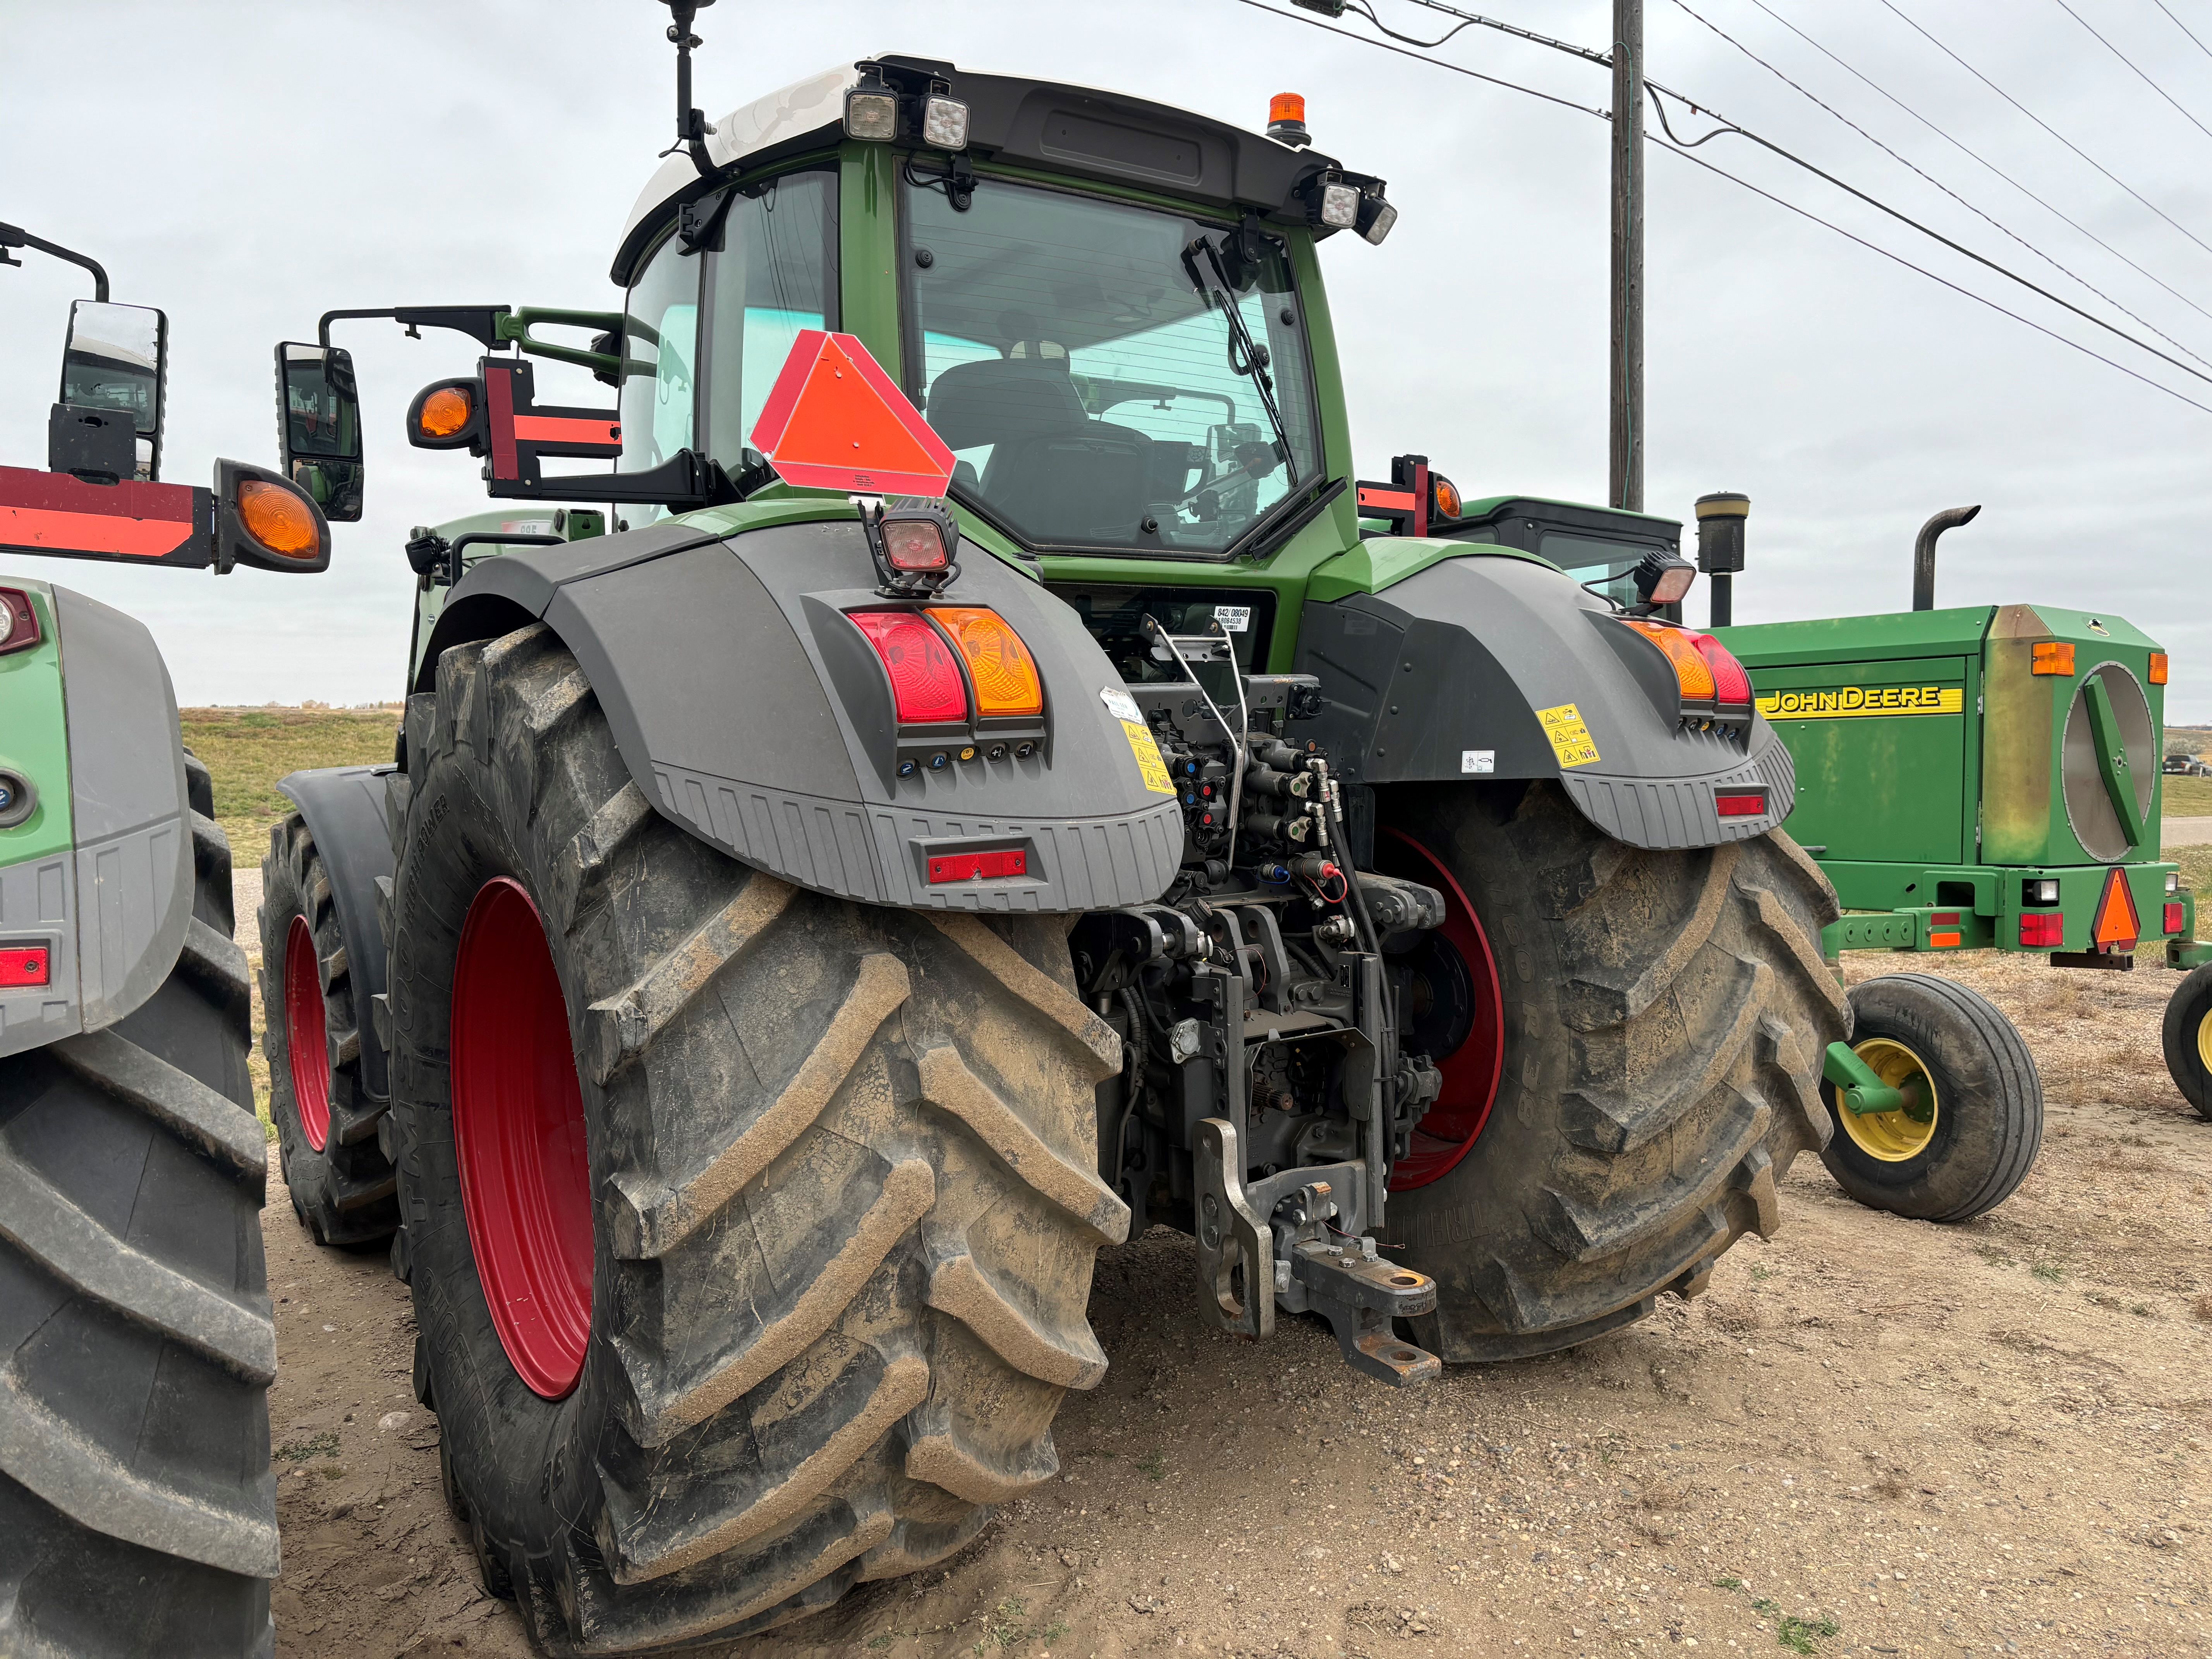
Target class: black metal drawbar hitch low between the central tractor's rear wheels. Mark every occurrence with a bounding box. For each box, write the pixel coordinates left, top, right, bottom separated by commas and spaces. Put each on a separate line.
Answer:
1192, 1117, 1444, 1389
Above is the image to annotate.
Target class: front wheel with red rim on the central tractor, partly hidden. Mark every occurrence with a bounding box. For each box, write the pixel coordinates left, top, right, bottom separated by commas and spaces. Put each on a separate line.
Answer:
261, 812, 400, 1245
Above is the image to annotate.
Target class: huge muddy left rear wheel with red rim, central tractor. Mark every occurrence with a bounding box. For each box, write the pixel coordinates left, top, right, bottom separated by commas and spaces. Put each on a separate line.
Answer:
387, 624, 1128, 1655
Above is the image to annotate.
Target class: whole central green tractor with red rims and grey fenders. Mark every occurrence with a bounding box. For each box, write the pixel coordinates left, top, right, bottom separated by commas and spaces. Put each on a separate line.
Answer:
261, 32, 1849, 1655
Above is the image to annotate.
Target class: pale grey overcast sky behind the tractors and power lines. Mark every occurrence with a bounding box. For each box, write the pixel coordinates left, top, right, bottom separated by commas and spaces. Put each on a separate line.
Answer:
0, 0, 2212, 721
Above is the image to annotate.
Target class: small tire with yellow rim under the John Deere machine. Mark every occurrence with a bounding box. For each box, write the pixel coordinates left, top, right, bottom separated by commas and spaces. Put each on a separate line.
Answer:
1820, 973, 2044, 1221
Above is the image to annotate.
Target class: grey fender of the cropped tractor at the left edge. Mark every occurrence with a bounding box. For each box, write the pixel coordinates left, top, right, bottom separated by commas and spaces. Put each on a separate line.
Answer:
0, 584, 192, 1055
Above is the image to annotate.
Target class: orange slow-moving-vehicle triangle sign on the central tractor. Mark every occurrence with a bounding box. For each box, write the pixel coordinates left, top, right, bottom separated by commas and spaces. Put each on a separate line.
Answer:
752, 327, 953, 495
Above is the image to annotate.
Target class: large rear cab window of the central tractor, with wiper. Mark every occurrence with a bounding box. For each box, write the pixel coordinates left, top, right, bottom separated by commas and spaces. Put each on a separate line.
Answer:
902, 179, 1321, 555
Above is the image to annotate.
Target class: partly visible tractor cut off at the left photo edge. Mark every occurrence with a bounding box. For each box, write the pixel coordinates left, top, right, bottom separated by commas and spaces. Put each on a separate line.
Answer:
0, 226, 330, 1659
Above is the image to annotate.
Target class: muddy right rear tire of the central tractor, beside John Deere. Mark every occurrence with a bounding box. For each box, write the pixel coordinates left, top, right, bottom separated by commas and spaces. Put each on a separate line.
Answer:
1378, 783, 1851, 1360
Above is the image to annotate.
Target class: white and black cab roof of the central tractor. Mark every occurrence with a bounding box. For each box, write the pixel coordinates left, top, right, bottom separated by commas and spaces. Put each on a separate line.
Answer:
608, 53, 1336, 288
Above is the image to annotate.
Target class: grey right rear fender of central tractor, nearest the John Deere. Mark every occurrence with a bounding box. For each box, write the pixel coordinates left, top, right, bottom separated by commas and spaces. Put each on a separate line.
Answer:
1296, 555, 1796, 849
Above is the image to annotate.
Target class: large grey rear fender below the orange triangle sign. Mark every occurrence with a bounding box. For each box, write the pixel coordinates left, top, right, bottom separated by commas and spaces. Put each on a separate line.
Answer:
416, 517, 1183, 914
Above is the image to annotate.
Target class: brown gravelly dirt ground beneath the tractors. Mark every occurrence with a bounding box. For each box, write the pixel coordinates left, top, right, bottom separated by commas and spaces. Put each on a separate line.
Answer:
241, 946, 2212, 1659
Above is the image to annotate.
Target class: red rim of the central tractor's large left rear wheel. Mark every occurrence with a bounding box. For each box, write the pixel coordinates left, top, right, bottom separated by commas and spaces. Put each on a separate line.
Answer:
451, 876, 591, 1400
